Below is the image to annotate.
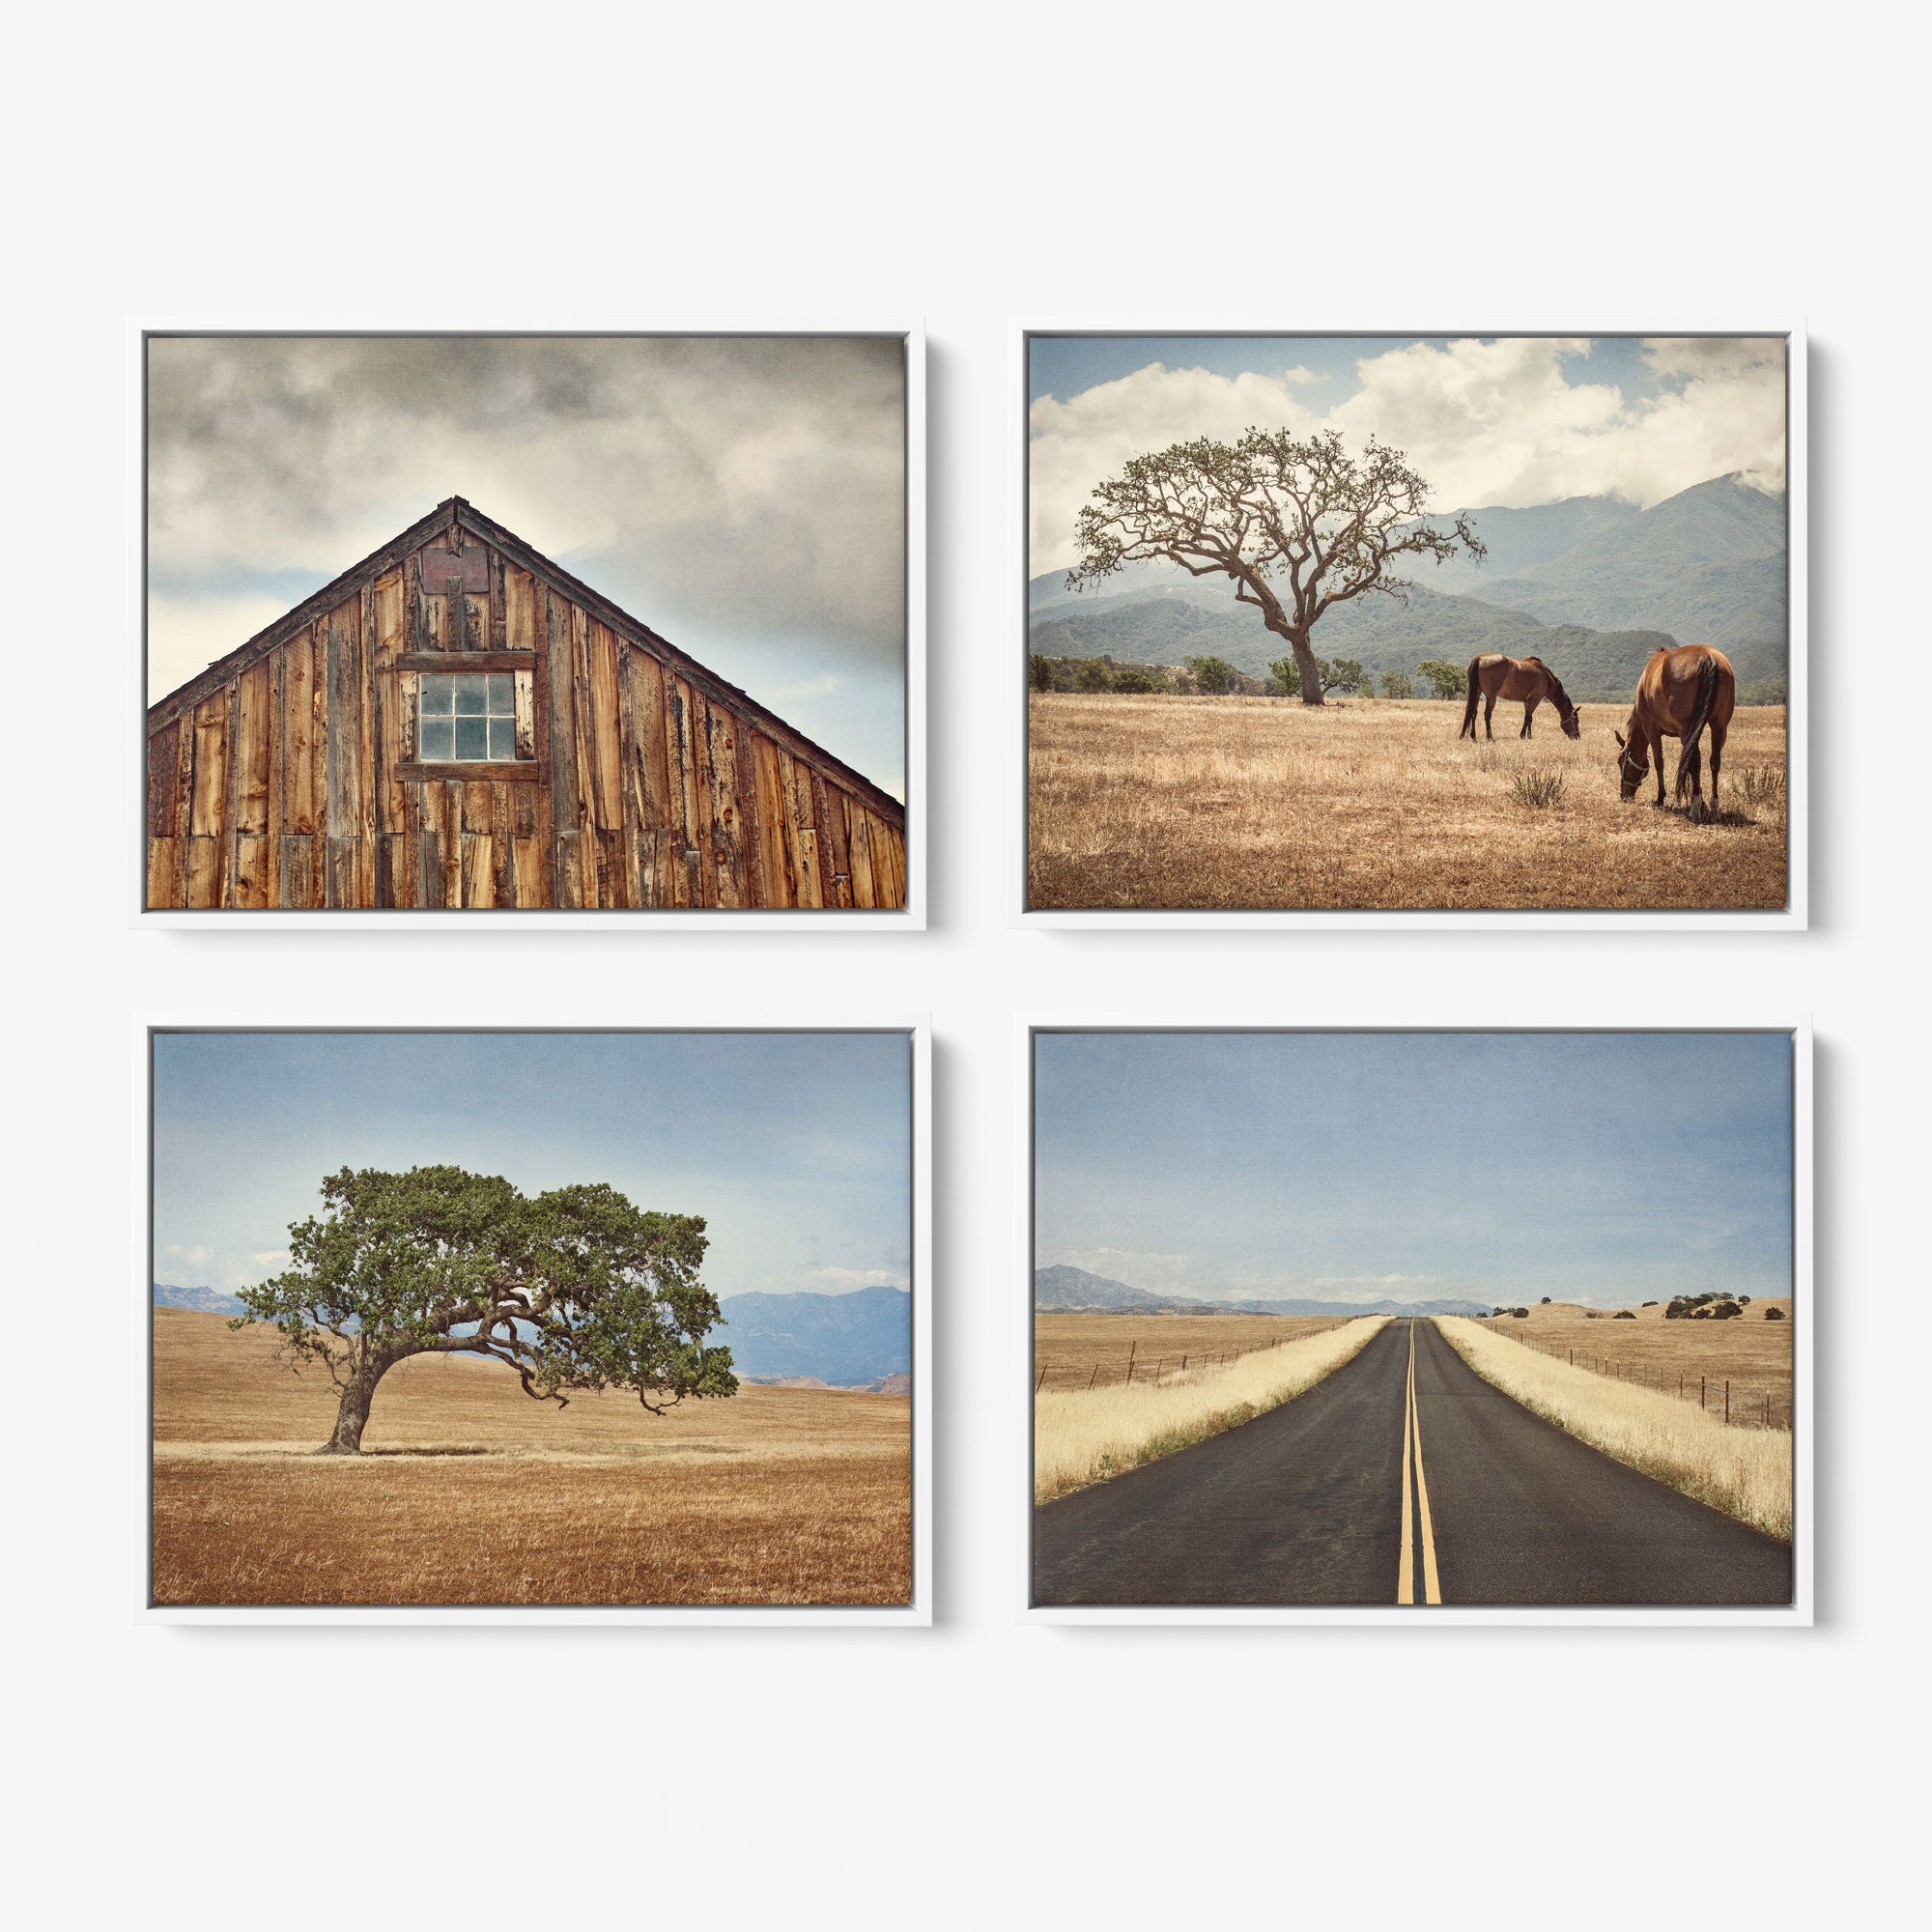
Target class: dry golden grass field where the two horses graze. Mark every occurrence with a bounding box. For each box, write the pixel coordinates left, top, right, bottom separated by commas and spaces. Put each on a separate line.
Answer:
1028, 692, 1785, 910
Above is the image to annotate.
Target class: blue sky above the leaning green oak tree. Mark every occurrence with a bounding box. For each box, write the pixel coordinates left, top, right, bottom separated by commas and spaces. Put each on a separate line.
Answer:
155, 1034, 912, 1294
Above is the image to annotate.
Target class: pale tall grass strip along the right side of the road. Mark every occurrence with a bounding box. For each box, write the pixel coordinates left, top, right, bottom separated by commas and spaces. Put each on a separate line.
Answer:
1435, 1316, 1791, 1542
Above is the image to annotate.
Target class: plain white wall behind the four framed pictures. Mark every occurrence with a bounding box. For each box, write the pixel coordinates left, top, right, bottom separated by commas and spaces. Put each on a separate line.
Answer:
0, 4, 1928, 1926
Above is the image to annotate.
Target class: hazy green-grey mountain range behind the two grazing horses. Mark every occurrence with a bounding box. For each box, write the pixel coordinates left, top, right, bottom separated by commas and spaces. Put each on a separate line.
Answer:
1028, 475, 1789, 703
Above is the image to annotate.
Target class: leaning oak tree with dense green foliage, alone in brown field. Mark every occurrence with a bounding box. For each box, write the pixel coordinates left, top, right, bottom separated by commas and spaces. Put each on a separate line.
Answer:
228, 1167, 738, 1455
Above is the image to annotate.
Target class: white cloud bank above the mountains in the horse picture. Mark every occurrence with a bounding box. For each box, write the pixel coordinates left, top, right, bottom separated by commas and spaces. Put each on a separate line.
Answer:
1030, 336, 1785, 574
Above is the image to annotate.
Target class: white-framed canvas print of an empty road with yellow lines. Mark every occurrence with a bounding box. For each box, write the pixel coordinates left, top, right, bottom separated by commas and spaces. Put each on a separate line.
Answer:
1018, 1016, 1814, 1627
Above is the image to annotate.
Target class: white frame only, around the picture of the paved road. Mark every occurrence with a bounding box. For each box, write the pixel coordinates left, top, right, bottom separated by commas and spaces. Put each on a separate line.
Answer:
1012, 1012, 1818, 1629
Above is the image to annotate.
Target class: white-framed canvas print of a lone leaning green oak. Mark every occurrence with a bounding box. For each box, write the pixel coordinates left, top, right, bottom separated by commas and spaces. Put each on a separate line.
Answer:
135, 1016, 931, 1627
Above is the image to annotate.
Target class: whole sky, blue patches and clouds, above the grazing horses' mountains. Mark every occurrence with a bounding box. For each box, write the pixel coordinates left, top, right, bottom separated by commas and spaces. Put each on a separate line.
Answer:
1028, 336, 1785, 576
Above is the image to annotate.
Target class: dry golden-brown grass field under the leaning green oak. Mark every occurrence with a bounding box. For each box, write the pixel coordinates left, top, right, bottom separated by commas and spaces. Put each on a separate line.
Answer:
153, 1308, 912, 1604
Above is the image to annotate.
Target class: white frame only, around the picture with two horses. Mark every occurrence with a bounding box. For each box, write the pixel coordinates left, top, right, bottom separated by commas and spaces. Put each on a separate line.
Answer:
1007, 317, 1810, 933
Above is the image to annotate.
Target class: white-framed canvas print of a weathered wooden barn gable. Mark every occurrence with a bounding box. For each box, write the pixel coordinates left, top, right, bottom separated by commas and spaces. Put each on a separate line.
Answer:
131, 327, 923, 929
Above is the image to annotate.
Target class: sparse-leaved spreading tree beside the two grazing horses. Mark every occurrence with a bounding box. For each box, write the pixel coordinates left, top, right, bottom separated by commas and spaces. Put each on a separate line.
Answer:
1066, 429, 1488, 705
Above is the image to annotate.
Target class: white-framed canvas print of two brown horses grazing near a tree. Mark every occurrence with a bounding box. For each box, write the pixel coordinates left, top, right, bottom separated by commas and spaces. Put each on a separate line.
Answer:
1010, 323, 1806, 929
